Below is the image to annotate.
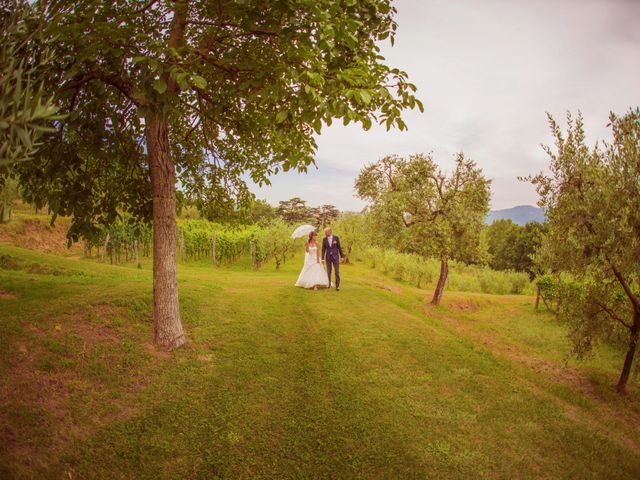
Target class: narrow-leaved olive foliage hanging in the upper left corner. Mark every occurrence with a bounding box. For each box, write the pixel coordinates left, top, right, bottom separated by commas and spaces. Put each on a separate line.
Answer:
0, 0, 61, 166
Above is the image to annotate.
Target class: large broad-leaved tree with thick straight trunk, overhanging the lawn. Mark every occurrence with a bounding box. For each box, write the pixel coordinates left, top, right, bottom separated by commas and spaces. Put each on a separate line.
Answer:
20, 0, 422, 348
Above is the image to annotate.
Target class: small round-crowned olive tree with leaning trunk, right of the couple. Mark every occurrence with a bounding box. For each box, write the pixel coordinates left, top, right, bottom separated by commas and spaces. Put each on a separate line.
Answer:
356, 153, 490, 305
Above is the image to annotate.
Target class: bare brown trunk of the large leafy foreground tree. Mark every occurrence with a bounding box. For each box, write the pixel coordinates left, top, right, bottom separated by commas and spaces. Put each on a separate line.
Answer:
146, 114, 185, 348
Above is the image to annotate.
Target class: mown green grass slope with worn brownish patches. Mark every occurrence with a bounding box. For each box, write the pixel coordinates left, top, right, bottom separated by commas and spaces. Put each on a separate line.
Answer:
0, 246, 640, 479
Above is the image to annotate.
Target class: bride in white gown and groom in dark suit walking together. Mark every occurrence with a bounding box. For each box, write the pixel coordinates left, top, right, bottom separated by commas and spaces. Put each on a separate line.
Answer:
296, 228, 344, 291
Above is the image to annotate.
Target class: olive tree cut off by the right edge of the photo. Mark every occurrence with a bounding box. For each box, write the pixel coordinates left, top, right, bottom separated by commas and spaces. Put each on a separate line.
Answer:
528, 109, 640, 393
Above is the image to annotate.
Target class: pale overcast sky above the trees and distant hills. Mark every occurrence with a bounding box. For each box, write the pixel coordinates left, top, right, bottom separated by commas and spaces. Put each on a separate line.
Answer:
253, 0, 640, 210
